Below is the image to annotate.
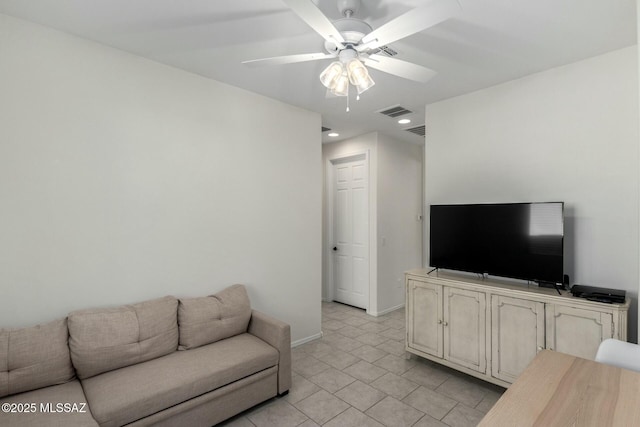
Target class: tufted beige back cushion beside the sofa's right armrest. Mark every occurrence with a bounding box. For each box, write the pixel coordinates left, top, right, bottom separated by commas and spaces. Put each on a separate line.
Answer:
178, 285, 251, 350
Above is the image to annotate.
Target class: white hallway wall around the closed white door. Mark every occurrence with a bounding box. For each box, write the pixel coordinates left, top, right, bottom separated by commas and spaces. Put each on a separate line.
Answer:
322, 132, 423, 315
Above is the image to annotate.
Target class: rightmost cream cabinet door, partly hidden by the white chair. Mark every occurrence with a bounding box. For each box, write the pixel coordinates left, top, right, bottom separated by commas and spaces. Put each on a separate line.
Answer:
546, 304, 613, 360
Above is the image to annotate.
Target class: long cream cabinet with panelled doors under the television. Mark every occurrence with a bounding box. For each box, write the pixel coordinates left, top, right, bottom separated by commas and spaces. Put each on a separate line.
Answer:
405, 269, 629, 387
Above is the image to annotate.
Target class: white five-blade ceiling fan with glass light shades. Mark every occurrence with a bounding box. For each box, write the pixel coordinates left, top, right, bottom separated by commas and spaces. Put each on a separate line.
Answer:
243, 0, 461, 101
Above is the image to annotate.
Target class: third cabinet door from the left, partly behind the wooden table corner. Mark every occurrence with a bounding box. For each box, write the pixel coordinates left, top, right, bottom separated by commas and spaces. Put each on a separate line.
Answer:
491, 295, 545, 383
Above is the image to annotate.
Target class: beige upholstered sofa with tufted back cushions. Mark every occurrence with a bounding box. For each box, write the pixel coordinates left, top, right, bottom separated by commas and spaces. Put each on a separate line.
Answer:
0, 285, 291, 427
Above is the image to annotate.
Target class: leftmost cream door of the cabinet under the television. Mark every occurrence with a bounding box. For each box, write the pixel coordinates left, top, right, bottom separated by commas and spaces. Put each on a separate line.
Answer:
407, 279, 442, 357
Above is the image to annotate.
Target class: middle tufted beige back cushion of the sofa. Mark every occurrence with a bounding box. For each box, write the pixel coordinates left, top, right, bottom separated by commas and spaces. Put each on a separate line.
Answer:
69, 296, 178, 379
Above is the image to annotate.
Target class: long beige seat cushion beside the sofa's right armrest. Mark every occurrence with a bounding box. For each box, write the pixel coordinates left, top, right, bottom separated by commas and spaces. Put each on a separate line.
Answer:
82, 333, 279, 427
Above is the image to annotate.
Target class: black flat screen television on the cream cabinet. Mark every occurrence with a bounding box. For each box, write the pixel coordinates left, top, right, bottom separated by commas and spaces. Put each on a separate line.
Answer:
429, 202, 564, 283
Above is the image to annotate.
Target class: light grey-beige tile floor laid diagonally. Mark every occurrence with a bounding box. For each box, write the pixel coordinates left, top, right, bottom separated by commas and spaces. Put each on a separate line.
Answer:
223, 303, 504, 427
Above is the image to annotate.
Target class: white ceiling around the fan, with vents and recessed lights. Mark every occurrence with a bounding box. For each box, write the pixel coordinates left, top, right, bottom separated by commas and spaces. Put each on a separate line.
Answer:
0, 0, 636, 143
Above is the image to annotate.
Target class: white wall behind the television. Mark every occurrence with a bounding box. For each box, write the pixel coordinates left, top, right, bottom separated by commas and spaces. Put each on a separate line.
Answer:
425, 46, 639, 340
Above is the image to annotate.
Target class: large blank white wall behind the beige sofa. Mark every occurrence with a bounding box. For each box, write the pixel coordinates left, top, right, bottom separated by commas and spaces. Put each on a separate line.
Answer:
0, 15, 322, 341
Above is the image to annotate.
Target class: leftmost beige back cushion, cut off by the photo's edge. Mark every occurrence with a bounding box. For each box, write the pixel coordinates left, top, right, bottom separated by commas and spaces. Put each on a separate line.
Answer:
0, 319, 75, 397
